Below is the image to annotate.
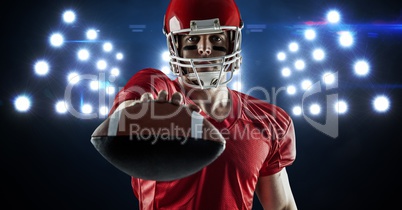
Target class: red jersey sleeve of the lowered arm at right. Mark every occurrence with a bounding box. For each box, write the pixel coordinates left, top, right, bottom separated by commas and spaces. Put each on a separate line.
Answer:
260, 119, 296, 176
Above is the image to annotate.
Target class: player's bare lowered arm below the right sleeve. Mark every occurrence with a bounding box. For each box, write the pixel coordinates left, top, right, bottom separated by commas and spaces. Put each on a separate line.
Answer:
255, 168, 297, 210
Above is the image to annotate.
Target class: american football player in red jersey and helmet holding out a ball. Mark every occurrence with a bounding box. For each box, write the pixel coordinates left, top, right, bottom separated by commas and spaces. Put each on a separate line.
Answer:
110, 0, 297, 210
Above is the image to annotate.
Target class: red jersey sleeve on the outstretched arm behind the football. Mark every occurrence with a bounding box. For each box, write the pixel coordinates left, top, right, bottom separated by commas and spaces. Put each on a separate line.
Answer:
109, 68, 170, 115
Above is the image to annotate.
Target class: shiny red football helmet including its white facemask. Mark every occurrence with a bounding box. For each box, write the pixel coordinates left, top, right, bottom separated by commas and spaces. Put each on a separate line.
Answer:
163, 0, 243, 89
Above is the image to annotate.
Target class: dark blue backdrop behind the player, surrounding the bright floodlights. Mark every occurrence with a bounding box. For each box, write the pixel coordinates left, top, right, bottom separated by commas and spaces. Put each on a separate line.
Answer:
0, 0, 402, 210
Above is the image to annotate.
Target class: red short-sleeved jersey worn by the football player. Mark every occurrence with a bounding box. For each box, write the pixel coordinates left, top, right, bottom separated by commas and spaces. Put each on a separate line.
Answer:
111, 69, 296, 210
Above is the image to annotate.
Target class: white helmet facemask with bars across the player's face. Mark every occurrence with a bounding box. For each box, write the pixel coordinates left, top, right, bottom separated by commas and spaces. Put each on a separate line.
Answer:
166, 18, 241, 89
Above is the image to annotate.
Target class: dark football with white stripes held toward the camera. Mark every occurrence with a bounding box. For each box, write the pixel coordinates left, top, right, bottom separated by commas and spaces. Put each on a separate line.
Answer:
91, 101, 225, 181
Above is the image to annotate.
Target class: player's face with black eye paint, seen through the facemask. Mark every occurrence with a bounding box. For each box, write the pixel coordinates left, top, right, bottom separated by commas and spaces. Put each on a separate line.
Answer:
179, 32, 229, 72
